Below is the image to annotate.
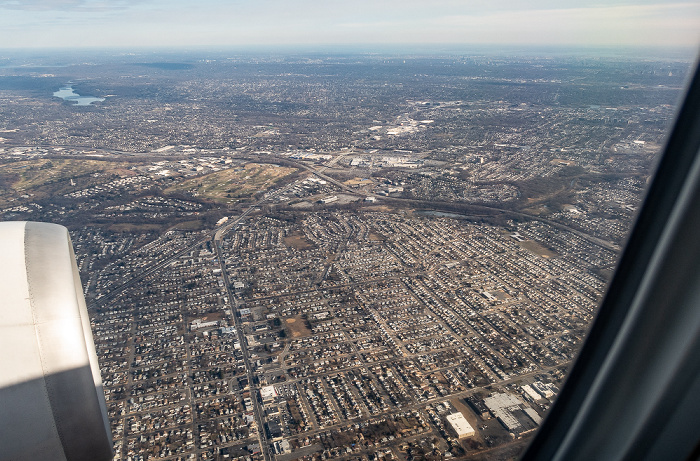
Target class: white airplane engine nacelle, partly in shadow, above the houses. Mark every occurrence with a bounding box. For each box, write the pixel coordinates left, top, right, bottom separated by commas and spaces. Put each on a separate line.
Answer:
0, 222, 112, 461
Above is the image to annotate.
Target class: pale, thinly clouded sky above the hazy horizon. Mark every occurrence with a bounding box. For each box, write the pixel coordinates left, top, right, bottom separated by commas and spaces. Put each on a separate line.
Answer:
0, 0, 700, 49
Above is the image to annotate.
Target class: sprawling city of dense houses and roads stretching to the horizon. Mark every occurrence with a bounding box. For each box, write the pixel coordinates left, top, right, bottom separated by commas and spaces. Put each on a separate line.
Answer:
0, 50, 690, 461
